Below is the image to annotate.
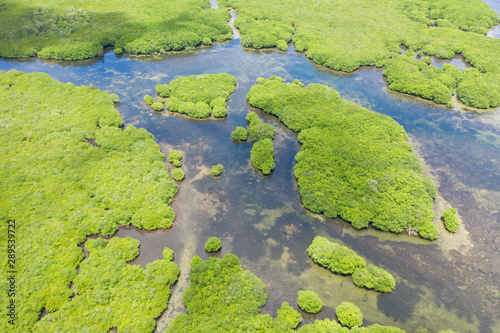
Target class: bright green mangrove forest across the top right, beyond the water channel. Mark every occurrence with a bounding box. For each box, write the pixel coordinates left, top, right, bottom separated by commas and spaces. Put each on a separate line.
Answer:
219, 0, 500, 109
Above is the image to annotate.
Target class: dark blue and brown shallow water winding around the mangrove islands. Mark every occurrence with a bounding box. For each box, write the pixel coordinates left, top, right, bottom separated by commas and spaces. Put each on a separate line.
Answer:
0, 5, 500, 332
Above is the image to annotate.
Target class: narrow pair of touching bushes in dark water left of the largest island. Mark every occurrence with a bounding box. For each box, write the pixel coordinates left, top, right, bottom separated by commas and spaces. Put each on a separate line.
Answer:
245, 112, 275, 175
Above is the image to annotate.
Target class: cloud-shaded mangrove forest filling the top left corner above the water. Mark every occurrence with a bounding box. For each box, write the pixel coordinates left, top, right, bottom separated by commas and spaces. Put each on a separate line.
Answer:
0, 0, 232, 60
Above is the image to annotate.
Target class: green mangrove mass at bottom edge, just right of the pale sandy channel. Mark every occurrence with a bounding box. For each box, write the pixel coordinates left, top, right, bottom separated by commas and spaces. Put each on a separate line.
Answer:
166, 254, 301, 333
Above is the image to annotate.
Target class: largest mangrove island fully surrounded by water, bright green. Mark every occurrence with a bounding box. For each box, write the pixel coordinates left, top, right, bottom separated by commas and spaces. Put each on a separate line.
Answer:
247, 76, 439, 240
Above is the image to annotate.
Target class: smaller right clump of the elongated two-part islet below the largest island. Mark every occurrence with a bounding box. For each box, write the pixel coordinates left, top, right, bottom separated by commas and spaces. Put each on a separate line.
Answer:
352, 265, 396, 293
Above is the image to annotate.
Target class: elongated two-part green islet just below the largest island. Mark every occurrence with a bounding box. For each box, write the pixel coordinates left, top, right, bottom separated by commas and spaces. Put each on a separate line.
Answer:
307, 236, 396, 293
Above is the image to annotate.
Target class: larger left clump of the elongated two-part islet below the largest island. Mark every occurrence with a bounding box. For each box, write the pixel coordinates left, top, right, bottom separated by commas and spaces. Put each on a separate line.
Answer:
307, 236, 366, 275
